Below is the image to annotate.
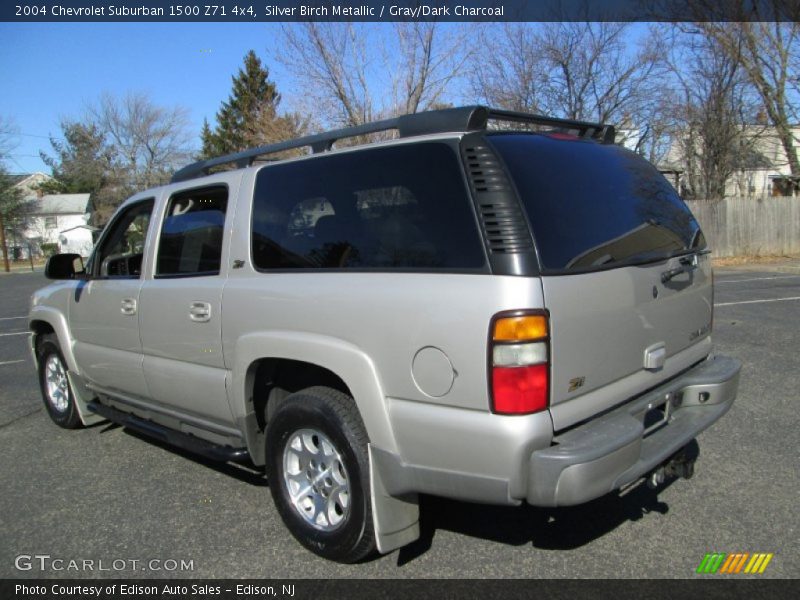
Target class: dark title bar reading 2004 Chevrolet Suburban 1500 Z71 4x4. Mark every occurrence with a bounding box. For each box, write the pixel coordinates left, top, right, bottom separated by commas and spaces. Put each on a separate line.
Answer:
0, 0, 800, 23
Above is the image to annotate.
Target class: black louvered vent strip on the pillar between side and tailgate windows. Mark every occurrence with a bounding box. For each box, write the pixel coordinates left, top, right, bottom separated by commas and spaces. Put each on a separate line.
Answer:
464, 144, 533, 253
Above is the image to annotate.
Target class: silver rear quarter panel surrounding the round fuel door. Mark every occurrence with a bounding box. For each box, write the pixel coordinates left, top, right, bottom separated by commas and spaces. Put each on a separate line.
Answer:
222, 172, 543, 450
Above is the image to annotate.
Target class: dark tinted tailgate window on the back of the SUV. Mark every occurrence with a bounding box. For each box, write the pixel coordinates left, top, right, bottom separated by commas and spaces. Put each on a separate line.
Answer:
489, 134, 706, 272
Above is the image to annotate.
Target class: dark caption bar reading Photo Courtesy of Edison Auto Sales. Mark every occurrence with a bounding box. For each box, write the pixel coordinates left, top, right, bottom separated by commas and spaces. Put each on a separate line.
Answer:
0, 576, 797, 600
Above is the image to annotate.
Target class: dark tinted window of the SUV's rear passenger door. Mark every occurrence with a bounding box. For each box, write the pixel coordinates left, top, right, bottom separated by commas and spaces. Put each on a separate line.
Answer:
156, 186, 228, 276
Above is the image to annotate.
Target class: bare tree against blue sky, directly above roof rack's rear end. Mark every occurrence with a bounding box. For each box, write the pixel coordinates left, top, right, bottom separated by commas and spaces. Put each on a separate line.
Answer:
471, 22, 664, 132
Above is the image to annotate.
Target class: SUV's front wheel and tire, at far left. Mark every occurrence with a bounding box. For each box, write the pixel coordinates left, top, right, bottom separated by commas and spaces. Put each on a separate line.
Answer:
38, 333, 82, 429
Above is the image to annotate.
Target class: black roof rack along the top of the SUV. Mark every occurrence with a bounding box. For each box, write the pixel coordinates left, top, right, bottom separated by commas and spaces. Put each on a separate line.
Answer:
172, 106, 615, 183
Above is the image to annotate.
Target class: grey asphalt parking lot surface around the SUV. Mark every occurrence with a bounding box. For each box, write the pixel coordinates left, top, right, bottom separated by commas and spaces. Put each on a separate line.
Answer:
0, 269, 800, 578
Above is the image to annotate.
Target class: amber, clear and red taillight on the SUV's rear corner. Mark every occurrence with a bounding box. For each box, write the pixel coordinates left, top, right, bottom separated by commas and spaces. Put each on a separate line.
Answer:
489, 311, 550, 415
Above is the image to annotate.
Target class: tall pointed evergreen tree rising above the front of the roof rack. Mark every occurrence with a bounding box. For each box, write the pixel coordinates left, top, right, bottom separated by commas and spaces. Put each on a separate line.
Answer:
200, 50, 298, 158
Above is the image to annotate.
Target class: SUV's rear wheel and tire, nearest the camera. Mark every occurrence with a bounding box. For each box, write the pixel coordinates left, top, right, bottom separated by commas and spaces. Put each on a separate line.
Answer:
266, 387, 375, 563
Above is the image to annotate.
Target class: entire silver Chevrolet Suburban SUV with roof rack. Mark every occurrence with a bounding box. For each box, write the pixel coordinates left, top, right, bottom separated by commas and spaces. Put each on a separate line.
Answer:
30, 107, 740, 562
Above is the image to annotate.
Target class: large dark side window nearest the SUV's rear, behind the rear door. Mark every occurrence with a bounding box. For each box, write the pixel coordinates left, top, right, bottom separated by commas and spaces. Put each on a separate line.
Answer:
252, 143, 486, 270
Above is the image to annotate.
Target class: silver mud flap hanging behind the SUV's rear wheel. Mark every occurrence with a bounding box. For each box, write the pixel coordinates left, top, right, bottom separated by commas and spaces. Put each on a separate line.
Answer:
369, 444, 419, 554
